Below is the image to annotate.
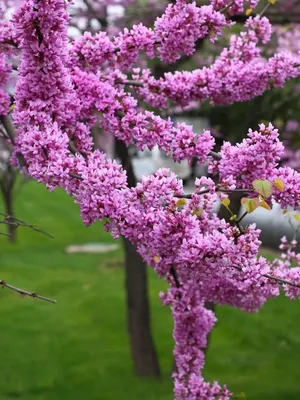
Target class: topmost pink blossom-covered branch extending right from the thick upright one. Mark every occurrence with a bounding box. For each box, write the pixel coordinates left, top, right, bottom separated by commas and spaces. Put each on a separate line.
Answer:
71, 0, 228, 70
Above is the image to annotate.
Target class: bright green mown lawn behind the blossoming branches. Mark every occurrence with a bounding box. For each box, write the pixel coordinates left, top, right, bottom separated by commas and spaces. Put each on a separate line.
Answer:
0, 182, 300, 400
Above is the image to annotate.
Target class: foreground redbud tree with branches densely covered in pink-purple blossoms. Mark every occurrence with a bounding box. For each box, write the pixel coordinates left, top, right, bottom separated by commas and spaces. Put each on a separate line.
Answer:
0, 0, 300, 400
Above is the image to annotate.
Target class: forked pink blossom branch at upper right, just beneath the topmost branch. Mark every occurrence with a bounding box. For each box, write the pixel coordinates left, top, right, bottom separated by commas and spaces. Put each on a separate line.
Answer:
133, 17, 300, 108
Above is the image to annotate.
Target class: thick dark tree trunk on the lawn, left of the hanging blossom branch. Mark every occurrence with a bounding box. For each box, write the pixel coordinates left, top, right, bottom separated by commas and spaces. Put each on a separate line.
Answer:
116, 139, 160, 378
